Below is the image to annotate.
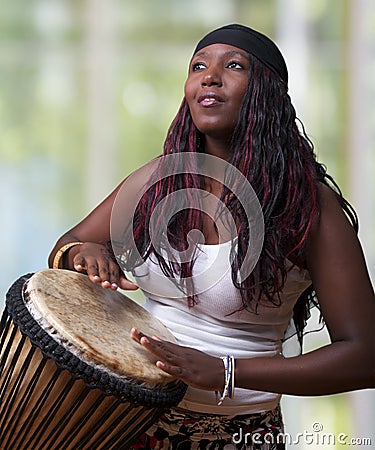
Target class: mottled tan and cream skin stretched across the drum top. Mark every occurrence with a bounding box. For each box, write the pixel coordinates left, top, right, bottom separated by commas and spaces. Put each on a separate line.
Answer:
24, 269, 175, 386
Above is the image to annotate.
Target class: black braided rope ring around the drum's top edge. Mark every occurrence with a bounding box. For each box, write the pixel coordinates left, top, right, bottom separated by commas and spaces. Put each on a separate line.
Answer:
5, 273, 187, 408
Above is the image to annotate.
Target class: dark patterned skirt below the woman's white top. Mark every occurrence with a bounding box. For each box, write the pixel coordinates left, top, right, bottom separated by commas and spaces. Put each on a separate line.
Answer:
131, 407, 285, 450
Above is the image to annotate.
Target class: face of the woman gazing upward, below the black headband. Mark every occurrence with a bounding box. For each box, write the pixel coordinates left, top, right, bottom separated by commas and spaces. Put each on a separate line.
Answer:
185, 44, 249, 140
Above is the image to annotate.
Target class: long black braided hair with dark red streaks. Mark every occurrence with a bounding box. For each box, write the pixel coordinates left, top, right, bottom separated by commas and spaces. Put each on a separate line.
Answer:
122, 55, 358, 344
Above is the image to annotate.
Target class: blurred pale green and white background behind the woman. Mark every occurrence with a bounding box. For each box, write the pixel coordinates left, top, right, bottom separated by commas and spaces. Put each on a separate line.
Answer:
0, 0, 375, 449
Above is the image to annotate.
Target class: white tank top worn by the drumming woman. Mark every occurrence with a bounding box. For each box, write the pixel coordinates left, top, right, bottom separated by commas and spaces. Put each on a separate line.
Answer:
134, 242, 311, 415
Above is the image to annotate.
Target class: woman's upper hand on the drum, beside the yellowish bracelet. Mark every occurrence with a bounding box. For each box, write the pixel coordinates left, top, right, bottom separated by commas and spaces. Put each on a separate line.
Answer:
72, 242, 138, 290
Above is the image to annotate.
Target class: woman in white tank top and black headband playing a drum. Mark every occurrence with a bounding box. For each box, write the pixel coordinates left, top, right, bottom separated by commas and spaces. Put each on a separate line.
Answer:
49, 25, 374, 449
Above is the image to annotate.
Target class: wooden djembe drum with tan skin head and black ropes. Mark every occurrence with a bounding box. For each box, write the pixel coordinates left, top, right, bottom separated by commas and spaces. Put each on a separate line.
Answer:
0, 269, 186, 450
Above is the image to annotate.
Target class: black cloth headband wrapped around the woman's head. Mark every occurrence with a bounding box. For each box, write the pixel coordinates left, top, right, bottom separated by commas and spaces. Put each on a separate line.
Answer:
193, 24, 288, 84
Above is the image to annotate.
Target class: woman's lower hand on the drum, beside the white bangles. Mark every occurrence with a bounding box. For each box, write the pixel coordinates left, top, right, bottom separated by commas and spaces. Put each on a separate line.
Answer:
131, 328, 224, 391
